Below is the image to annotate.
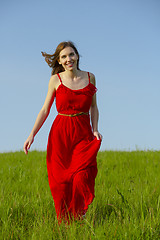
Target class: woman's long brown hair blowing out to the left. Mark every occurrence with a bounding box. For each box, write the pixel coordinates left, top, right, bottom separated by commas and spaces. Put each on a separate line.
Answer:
41, 41, 80, 75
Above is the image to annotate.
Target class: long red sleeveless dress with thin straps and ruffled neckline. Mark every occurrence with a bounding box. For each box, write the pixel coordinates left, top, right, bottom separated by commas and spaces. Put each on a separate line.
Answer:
47, 73, 101, 222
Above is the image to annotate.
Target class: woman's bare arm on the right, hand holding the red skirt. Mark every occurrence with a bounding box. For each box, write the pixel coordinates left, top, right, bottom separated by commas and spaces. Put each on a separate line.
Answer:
90, 74, 102, 140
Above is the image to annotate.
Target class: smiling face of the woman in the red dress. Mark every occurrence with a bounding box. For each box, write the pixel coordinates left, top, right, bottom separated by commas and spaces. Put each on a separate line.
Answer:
59, 47, 78, 70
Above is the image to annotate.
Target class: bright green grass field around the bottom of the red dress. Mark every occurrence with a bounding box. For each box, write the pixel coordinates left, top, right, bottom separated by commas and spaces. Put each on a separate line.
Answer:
0, 151, 160, 240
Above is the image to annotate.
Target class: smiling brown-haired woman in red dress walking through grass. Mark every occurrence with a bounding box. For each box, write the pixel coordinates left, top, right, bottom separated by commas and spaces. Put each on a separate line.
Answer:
24, 41, 102, 222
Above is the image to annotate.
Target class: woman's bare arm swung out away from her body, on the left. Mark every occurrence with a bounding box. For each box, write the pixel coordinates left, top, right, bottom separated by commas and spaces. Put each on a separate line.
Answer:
23, 75, 57, 154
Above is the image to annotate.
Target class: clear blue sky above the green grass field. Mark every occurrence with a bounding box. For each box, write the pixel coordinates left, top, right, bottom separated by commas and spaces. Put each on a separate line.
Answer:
0, 0, 160, 152
